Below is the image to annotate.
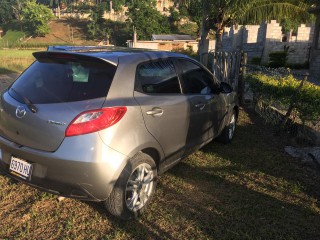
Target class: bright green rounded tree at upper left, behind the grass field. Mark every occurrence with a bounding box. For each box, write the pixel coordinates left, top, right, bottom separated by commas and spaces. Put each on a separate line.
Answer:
22, 0, 53, 36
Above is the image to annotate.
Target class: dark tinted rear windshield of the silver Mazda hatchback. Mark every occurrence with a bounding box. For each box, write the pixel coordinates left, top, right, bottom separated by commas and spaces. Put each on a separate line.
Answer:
9, 59, 116, 104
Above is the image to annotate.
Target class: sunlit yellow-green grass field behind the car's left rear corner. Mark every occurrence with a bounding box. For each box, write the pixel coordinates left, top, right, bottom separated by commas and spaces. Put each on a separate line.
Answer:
0, 49, 39, 74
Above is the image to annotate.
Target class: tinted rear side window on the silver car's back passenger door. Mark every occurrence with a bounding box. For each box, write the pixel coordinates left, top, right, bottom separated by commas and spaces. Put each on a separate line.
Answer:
136, 60, 181, 93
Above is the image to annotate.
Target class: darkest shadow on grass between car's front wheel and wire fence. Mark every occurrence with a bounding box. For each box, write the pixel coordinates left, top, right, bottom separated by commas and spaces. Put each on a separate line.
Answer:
200, 109, 320, 199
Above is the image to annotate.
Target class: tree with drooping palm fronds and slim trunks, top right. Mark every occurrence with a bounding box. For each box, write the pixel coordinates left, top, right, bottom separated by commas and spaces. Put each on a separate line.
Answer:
184, 0, 309, 61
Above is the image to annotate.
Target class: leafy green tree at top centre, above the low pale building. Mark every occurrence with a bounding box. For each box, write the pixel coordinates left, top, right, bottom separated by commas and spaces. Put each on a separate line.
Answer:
127, 0, 170, 40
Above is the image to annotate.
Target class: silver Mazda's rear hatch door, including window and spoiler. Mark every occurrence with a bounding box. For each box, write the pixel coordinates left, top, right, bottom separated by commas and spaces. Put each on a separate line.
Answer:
0, 52, 116, 151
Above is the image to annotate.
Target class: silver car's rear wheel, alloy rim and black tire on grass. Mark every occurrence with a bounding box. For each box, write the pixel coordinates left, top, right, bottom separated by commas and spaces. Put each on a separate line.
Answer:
105, 152, 157, 220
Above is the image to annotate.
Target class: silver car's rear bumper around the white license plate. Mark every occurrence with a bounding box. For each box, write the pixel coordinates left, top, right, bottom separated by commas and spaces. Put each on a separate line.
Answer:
0, 133, 128, 201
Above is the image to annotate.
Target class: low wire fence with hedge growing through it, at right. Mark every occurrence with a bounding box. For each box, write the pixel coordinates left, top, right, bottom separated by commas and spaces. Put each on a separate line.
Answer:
242, 64, 320, 142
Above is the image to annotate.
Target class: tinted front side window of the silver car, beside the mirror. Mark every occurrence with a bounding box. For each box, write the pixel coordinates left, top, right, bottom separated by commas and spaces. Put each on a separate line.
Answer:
178, 59, 215, 94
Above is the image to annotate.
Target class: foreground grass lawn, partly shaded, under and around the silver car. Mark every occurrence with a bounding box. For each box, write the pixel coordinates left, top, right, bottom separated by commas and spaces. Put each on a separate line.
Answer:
0, 110, 320, 239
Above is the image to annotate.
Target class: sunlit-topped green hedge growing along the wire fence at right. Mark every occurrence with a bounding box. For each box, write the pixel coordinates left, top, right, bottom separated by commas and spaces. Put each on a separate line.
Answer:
246, 74, 320, 121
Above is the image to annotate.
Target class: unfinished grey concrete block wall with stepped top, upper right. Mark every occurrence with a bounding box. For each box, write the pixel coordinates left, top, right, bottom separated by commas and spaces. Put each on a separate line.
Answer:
222, 20, 319, 66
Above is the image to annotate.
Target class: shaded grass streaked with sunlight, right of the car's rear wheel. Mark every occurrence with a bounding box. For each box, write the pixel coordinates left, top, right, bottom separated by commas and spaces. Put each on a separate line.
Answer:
87, 108, 320, 239
